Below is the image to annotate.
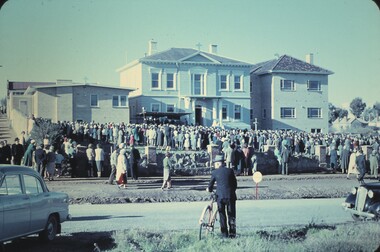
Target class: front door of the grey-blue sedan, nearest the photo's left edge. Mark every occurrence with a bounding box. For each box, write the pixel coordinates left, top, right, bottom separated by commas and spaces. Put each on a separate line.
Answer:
1, 174, 30, 239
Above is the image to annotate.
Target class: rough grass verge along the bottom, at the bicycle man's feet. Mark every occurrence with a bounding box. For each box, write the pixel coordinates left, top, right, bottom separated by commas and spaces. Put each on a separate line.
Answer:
108, 222, 380, 252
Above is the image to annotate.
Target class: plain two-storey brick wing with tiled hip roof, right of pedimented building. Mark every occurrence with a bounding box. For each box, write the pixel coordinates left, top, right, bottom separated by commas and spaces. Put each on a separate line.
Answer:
251, 54, 333, 133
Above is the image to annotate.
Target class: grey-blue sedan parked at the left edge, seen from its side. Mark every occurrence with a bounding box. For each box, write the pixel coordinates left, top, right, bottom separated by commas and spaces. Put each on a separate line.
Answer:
0, 165, 70, 245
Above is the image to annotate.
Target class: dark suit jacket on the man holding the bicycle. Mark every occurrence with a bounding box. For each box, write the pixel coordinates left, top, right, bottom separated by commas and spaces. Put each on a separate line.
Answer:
208, 166, 237, 201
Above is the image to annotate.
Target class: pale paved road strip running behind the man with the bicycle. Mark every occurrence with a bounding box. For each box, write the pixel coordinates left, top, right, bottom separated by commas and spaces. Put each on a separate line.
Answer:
62, 198, 353, 233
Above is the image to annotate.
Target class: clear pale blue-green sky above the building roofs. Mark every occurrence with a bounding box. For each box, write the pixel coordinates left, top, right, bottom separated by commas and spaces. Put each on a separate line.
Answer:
0, 0, 380, 107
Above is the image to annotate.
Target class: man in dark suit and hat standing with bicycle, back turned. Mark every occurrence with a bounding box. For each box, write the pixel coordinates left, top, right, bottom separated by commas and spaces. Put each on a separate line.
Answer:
206, 155, 237, 238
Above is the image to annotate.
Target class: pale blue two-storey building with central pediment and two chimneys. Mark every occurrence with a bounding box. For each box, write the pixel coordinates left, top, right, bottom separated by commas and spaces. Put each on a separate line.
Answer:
117, 41, 252, 128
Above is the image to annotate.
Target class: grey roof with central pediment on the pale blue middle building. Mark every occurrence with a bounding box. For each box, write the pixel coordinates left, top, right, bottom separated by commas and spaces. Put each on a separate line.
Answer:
117, 48, 252, 71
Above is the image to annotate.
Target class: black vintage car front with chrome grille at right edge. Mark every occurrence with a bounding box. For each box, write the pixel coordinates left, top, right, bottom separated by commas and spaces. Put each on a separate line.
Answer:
343, 182, 380, 220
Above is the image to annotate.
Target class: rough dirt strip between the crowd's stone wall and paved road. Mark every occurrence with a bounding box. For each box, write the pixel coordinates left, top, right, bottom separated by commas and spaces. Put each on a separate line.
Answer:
47, 174, 366, 204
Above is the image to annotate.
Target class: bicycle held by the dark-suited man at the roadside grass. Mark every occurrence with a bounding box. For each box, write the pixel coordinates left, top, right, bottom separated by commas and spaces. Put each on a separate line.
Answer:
199, 192, 218, 240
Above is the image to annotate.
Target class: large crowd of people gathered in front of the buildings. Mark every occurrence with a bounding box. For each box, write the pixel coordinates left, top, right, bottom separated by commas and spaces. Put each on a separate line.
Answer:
0, 118, 380, 183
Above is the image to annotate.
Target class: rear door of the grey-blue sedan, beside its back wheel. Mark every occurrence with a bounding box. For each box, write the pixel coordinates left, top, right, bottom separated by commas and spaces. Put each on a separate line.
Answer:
23, 175, 51, 231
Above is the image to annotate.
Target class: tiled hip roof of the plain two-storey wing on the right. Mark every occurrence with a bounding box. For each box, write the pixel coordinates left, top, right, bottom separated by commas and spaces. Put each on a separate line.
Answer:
251, 54, 333, 75
